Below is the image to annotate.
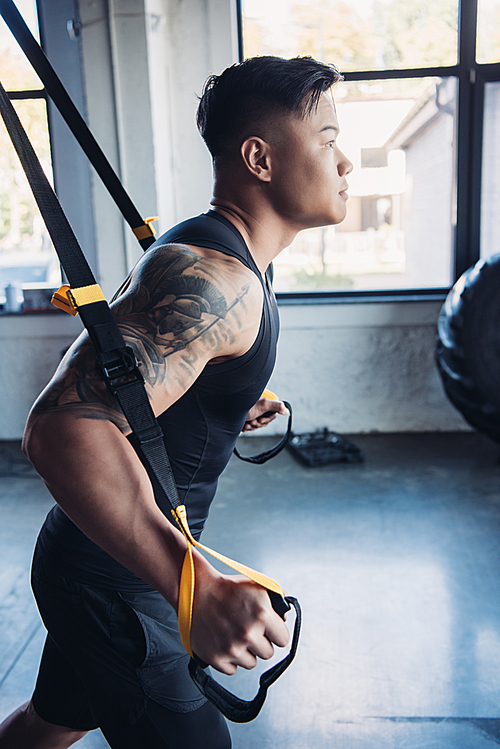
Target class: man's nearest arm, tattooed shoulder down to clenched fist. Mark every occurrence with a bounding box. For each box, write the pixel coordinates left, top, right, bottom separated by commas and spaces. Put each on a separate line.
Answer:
24, 246, 288, 673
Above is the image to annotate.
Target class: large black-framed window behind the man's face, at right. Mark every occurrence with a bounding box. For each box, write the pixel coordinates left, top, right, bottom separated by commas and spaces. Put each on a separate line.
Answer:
240, 0, 500, 298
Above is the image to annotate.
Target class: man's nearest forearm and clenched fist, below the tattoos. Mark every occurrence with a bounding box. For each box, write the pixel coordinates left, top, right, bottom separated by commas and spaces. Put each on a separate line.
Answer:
24, 412, 288, 674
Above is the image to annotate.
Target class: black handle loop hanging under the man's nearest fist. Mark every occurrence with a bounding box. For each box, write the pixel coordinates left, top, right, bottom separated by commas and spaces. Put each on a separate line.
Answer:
189, 592, 302, 723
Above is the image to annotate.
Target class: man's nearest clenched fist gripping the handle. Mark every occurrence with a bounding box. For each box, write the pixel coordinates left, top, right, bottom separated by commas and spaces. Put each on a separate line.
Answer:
191, 560, 290, 675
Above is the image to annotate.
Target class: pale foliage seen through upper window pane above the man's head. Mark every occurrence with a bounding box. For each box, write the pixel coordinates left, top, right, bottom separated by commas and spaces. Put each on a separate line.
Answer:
245, 0, 458, 71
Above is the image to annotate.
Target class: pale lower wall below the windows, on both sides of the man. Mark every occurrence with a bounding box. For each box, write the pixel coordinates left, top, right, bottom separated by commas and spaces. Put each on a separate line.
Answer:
0, 302, 469, 439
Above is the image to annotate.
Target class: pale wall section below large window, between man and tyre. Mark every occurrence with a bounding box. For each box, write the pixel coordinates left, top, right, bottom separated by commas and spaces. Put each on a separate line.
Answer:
269, 301, 469, 433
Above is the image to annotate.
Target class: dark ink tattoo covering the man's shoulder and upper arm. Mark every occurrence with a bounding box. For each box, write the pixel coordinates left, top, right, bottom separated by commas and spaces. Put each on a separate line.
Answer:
34, 246, 254, 433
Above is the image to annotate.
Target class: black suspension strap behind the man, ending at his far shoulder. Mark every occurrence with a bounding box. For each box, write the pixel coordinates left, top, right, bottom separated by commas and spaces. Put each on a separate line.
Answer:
0, 0, 156, 250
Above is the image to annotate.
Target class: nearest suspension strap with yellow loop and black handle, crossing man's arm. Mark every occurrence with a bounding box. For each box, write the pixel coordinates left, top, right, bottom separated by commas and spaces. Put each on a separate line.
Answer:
0, 77, 301, 722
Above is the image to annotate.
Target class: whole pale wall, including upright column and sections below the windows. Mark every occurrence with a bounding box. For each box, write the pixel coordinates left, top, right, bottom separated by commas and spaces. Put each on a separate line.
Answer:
0, 0, 468, 439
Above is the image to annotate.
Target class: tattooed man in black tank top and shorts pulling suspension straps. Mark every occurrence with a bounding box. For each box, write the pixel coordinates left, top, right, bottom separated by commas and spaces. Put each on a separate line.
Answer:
0, 57, 352, 749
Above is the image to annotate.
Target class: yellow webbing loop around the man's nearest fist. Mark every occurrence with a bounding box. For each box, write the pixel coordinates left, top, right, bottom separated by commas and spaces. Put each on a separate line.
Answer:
172, 505, 285, 657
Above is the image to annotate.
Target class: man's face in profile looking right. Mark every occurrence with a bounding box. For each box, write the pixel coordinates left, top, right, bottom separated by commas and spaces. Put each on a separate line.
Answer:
271, 94, 352, 230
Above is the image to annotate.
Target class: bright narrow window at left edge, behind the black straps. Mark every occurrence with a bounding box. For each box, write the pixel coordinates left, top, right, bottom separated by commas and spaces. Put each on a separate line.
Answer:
0, 0, 61, 311
